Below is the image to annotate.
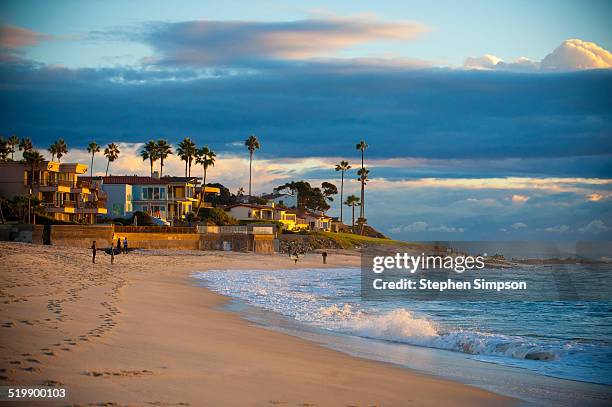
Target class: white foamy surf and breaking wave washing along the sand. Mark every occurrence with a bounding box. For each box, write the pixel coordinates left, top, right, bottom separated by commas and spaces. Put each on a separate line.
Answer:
198, 269, 610, 383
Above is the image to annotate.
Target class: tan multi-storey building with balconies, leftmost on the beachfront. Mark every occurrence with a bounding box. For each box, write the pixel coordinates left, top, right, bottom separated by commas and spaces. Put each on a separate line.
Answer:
0, 161, 107, 224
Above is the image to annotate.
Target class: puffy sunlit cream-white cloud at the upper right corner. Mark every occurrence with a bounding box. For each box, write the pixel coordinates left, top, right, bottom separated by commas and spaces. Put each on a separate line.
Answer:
463, 39, 612, 71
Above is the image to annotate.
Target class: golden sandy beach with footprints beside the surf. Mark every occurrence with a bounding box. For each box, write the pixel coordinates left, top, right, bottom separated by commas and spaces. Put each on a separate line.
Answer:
0, 242, 512, 406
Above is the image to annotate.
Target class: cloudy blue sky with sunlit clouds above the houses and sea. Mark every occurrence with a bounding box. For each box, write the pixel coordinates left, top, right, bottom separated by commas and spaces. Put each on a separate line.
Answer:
0, 0, 612, 240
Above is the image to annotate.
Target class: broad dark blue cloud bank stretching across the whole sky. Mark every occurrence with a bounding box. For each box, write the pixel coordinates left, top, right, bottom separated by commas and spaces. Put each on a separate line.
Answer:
0, 64, 612, 176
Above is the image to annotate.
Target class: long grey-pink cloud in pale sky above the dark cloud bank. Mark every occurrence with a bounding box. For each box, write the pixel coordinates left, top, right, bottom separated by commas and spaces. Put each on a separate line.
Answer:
137, 17, 426, 66
